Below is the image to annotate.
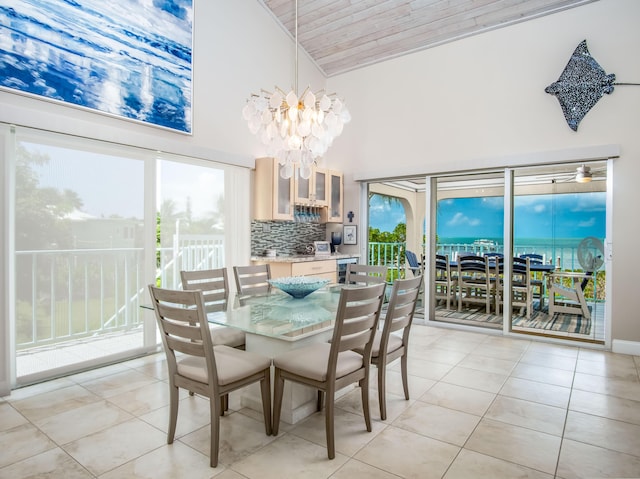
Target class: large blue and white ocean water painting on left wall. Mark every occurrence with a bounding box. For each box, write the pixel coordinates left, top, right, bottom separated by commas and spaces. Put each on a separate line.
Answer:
0, 0, 193, 133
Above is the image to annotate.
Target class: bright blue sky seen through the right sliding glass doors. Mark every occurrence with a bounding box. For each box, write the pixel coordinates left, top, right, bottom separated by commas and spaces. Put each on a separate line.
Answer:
369, 192, 606, 238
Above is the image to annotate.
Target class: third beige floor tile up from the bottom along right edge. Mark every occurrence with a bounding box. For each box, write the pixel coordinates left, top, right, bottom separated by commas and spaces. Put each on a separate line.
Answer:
569, 390, 640, 425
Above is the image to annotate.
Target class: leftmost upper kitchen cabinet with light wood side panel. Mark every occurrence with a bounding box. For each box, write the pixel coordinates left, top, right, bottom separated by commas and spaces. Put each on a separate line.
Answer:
253, 158, 294, 221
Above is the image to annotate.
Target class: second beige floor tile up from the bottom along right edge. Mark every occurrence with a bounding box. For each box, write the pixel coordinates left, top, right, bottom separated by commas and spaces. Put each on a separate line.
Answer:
564, 411, 640, 457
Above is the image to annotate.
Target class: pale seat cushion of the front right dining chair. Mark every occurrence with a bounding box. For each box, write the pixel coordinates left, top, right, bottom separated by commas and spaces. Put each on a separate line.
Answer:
273, 343, 363, 381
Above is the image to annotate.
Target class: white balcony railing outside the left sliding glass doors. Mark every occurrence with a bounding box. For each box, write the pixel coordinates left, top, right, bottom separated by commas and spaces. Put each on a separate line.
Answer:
15, 235, 224, 351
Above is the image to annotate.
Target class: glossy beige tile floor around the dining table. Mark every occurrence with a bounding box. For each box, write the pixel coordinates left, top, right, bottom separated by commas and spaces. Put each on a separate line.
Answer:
0, 324, 640, 479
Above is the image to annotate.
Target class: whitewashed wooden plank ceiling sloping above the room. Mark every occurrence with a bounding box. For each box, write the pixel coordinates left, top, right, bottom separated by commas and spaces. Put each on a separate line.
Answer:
258, 0, 597, 77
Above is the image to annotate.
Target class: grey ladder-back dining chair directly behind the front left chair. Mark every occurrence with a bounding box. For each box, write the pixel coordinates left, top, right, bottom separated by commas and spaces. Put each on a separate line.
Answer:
180, 268, 245, 349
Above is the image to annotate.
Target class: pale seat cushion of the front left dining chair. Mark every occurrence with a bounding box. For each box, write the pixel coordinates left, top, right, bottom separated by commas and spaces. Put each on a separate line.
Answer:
177, 346, 271, 386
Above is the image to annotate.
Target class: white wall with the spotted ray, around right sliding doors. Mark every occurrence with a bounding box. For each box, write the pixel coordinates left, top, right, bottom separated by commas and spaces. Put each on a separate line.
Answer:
328, 0, 640, 346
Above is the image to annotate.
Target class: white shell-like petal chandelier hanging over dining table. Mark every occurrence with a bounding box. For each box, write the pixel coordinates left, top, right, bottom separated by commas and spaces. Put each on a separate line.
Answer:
242, 0, 351, 179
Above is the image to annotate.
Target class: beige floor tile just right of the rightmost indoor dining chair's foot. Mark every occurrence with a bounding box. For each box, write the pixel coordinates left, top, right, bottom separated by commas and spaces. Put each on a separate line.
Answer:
418, 382, 496, 416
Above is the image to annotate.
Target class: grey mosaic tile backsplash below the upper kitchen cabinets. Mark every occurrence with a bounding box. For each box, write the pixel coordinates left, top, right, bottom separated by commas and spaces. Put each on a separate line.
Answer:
251, 220, 327, 256
